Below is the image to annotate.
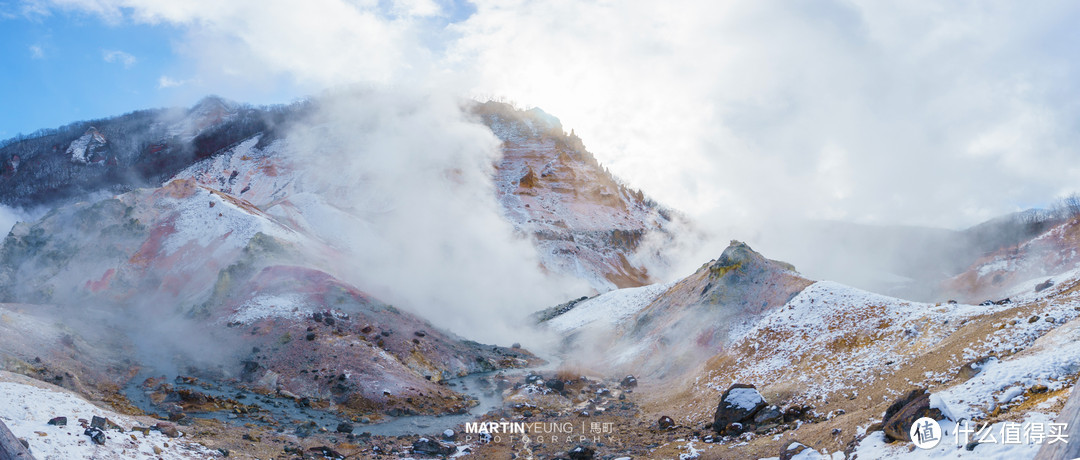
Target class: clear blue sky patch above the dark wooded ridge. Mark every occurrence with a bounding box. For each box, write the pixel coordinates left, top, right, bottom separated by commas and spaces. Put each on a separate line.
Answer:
0, 7, 297, 138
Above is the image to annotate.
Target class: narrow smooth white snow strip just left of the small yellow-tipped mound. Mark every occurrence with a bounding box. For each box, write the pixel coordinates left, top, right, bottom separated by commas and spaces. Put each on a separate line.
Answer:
546, 283, 674, 333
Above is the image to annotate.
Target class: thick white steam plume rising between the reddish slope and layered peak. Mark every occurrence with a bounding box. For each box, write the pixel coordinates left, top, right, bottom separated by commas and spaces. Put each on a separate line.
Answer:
278, 89, 588, 343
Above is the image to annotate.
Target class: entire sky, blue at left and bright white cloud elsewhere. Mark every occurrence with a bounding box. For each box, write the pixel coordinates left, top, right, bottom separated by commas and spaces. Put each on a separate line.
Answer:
0, 0, 1080, 228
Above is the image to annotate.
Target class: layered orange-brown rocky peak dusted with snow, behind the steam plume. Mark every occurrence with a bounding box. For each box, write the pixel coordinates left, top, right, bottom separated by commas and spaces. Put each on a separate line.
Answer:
472, 102, 677, 292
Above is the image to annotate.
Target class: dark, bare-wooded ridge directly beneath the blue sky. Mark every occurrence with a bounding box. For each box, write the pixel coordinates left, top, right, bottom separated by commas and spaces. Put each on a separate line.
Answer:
0, 97, 299, 207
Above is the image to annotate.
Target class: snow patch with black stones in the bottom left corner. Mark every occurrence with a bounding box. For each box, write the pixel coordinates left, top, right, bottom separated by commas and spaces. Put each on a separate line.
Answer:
0, 373, 220, 460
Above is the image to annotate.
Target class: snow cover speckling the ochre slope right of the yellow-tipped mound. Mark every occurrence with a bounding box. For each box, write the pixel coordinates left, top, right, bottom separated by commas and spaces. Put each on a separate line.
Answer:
708, 281, 1080, 401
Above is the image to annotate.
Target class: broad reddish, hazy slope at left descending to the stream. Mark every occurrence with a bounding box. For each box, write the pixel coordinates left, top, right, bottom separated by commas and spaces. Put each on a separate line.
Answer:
0, 179, 536, 416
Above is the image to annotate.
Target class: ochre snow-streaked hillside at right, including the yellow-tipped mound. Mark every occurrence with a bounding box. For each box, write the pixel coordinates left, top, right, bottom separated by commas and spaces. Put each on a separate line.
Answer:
541, 238, 1080, 458
